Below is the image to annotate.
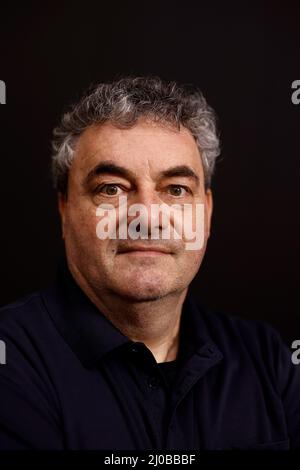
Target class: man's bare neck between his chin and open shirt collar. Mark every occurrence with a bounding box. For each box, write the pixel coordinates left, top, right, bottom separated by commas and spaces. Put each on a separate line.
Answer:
72, 266, 187, 362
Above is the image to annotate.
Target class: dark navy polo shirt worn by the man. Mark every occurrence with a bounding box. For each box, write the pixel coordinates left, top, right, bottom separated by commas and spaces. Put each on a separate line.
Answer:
0, 263, 300, 450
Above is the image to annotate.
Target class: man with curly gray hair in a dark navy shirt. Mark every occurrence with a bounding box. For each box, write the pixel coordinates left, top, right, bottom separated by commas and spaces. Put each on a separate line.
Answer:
0, 77, 300, 450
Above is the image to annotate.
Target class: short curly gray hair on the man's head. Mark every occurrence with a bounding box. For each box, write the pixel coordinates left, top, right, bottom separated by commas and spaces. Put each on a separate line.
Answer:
52, 76, 220, 195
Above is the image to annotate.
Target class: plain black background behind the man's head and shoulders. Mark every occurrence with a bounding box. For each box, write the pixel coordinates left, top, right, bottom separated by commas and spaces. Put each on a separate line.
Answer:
0, 1, 300, 344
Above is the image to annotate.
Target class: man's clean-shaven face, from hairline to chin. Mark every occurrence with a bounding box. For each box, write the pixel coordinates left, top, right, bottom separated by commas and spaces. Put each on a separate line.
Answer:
59, 119, 212, 301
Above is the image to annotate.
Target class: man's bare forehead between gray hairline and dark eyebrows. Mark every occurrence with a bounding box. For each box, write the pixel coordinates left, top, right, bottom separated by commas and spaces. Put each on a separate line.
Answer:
72, 120, 202, 179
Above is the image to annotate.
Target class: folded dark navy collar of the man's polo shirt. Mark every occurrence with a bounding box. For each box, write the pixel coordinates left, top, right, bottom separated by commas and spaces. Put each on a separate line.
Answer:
42, 257, 220, 368
